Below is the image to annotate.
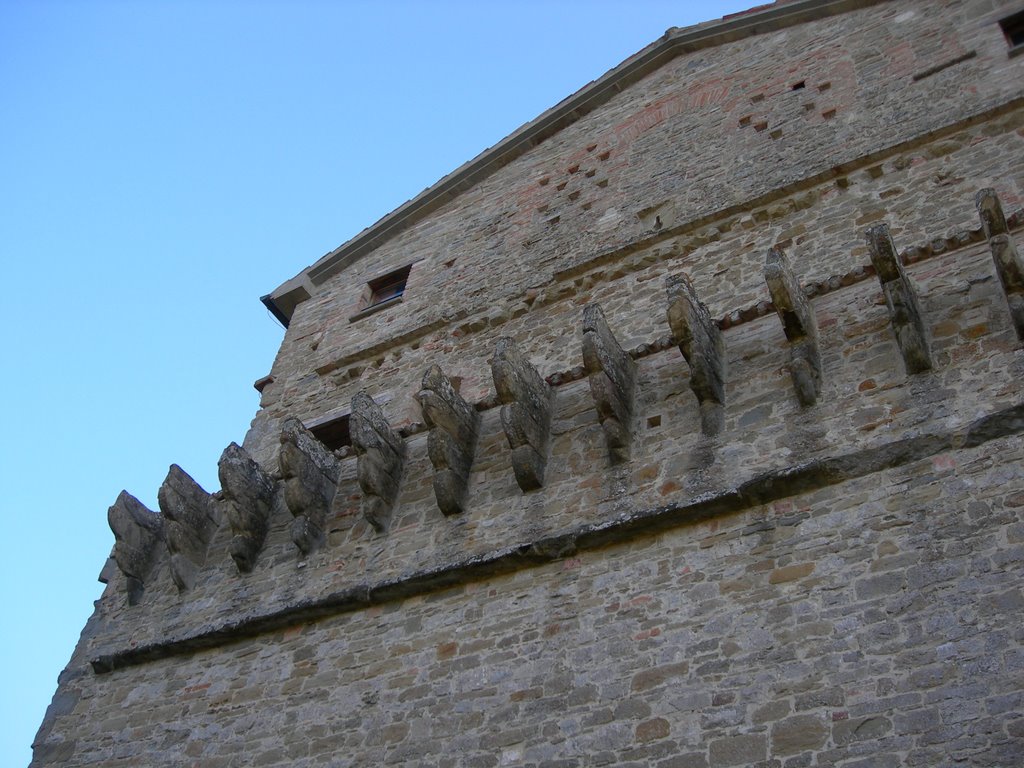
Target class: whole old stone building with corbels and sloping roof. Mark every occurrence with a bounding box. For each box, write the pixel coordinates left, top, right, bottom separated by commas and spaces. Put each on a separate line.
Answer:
33, 0, 1024, 768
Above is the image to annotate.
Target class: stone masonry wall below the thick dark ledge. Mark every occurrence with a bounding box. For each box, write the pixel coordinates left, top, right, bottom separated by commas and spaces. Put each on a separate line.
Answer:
32, 435, 1024, 768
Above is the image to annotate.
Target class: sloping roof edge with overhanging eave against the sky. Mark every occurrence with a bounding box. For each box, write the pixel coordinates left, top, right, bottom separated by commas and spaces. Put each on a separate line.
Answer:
260, 0, 888, 327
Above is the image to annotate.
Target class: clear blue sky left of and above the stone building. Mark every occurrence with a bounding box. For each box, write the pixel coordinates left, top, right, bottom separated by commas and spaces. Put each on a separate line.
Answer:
0, 0, 756, 766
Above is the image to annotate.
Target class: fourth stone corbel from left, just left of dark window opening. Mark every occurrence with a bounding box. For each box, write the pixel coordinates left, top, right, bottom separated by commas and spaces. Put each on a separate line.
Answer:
278, 417, 340, 555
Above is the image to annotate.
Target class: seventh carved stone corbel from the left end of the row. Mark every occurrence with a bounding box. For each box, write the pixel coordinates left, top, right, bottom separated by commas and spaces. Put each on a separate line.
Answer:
490, 336, 552, 492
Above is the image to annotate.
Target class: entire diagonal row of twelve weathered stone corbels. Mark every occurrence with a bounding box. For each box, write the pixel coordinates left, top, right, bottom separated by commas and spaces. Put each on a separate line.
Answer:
108, 189, 1024, 603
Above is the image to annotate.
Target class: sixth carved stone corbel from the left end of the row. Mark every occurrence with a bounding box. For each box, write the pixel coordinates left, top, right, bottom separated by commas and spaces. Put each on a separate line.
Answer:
416, 366, 480, 515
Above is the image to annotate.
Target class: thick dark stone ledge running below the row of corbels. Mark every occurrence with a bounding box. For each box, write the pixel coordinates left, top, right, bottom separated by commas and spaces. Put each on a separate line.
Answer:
90, 403, 1024, 674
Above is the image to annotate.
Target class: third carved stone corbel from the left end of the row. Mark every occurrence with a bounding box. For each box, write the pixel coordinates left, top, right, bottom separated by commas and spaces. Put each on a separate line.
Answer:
217, 442, 274, 573
